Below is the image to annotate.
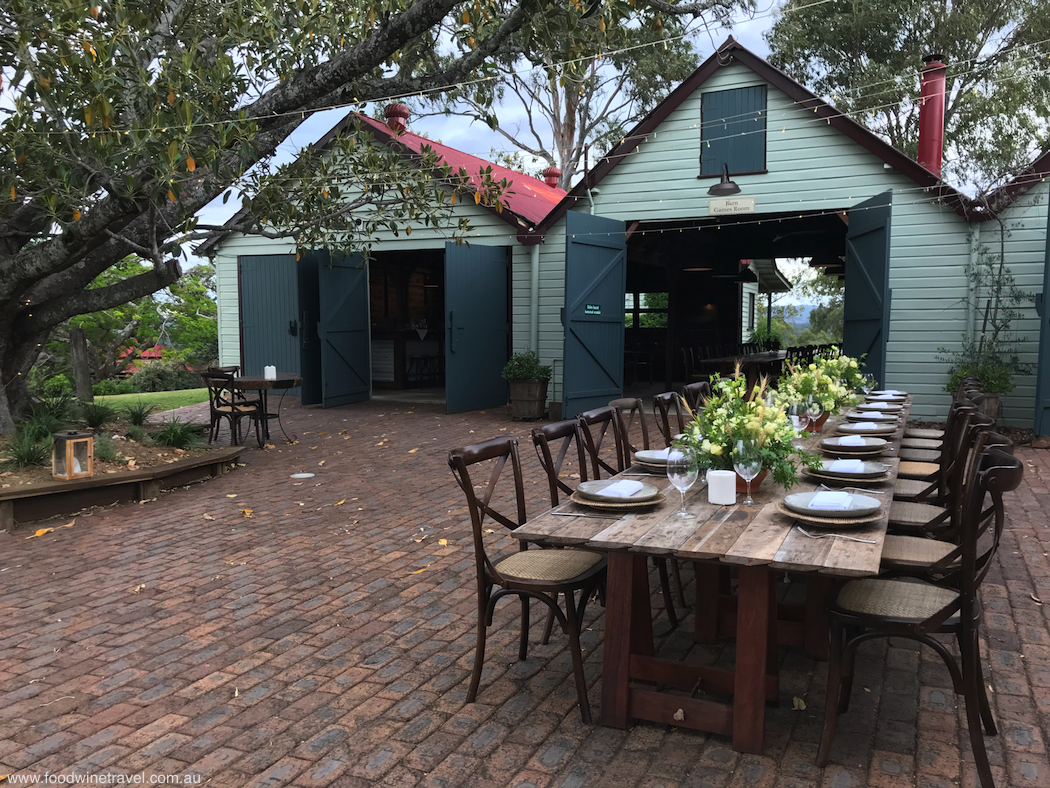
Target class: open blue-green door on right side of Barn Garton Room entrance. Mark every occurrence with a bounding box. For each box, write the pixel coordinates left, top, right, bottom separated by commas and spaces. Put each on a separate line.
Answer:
842, 191, 893, 386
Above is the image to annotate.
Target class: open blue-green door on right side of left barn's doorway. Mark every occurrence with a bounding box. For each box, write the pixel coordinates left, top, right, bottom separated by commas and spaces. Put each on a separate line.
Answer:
445, 242, 509, 413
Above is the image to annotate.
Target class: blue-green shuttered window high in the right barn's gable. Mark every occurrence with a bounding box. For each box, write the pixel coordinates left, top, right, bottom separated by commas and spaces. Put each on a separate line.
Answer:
700, 85, 765, 178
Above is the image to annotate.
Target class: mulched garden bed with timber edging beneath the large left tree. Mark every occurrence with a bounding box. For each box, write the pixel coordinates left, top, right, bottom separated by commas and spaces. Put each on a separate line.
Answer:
0, 441, 247, 531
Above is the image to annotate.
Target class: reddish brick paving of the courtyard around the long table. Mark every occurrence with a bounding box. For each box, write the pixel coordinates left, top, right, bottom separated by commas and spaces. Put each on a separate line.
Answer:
0, 402, 1050, 788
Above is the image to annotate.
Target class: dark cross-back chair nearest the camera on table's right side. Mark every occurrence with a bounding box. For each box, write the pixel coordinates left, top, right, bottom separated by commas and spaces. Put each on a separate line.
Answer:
817, 448, 1024, 788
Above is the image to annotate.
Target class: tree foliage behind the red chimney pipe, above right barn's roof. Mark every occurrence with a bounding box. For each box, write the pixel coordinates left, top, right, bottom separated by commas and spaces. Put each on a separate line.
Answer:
765, 0, 1050, 186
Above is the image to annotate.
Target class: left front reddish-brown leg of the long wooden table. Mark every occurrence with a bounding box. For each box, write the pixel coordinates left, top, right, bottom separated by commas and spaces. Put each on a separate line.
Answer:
602, 553, 653, 728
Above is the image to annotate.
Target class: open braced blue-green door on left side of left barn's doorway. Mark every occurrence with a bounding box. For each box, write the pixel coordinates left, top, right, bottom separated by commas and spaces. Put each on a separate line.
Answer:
308, 252, 372, 408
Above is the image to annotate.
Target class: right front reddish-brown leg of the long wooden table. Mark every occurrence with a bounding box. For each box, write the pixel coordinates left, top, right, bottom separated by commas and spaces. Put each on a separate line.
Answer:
733, 565, 776, 753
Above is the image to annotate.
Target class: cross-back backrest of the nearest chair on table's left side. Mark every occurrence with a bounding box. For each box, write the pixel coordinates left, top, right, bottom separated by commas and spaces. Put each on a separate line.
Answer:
448, 438, 525, 586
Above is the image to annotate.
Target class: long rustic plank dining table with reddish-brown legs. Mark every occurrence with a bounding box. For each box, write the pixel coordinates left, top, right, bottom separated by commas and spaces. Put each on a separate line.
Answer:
515, 402, 910, 753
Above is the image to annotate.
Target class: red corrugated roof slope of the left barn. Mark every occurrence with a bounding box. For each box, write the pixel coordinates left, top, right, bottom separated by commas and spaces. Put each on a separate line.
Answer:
355, 113, 565, 223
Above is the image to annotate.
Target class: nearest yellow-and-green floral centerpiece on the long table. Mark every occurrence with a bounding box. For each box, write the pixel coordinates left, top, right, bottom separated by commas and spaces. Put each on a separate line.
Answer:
677, 370, 820, 488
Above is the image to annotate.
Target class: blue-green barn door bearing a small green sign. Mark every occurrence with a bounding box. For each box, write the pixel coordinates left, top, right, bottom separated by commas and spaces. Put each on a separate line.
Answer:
562, 211, 627, 418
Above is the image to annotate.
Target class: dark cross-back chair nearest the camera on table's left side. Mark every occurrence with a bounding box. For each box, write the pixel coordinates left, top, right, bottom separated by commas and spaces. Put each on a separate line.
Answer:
448, 438, 606, 723
